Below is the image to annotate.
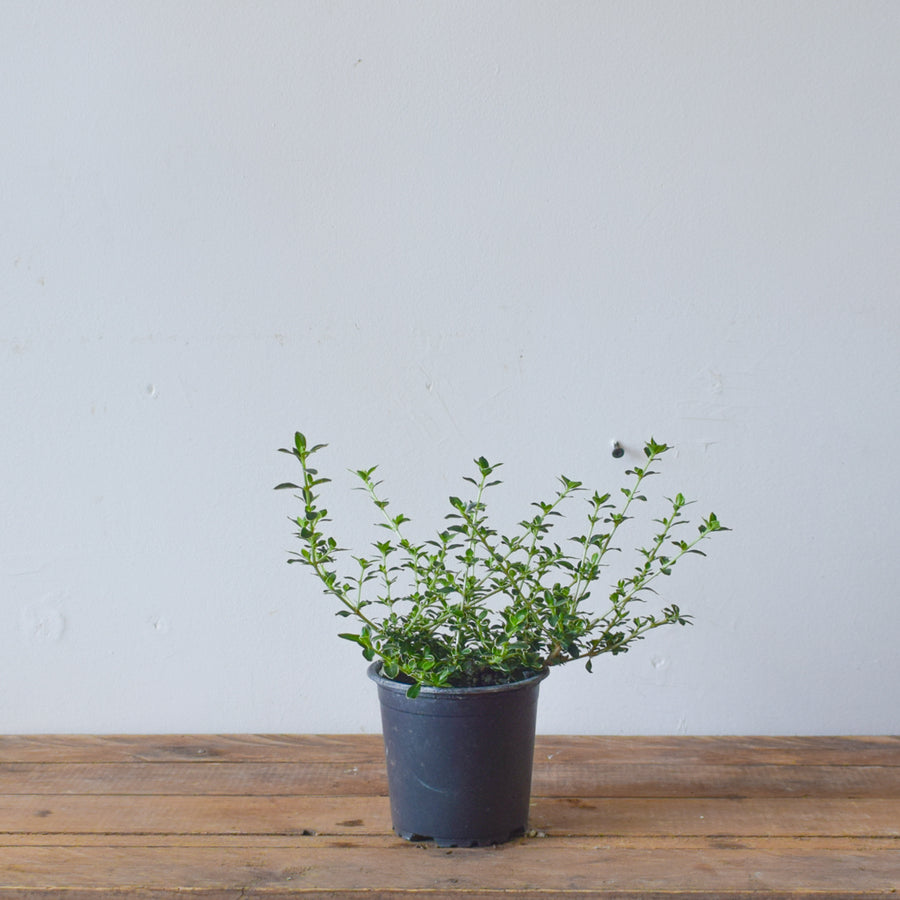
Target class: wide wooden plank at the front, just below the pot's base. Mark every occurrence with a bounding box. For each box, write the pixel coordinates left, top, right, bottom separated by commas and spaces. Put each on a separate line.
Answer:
0, 840, 900, 898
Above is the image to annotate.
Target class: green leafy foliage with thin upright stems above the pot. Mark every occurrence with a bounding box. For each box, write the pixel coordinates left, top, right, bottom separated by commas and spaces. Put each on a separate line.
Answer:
276, 432, 728, 696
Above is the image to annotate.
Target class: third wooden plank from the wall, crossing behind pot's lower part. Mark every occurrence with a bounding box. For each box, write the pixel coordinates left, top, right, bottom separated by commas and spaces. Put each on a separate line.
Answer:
0, 794, 900, 837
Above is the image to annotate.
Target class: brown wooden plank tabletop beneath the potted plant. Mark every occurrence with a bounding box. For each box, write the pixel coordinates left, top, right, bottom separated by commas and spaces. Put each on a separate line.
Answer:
0, 735, 900, 900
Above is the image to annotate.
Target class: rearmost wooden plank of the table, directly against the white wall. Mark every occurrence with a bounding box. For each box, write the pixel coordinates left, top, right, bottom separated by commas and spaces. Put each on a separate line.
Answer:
0, 734, 900, 766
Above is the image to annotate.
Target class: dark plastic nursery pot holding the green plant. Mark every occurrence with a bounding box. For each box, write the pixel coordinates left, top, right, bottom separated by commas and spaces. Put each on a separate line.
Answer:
368, 663, 547, 847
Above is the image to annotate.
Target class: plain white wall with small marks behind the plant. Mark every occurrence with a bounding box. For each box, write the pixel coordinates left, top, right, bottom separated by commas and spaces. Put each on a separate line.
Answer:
0, 0, 900, 733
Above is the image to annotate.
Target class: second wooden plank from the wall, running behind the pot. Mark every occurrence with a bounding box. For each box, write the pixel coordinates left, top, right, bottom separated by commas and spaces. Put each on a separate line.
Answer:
0, 760, 900, 799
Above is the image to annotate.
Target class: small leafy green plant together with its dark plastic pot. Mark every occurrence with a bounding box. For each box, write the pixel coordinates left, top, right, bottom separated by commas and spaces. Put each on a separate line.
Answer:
277, 432, 728, 846
